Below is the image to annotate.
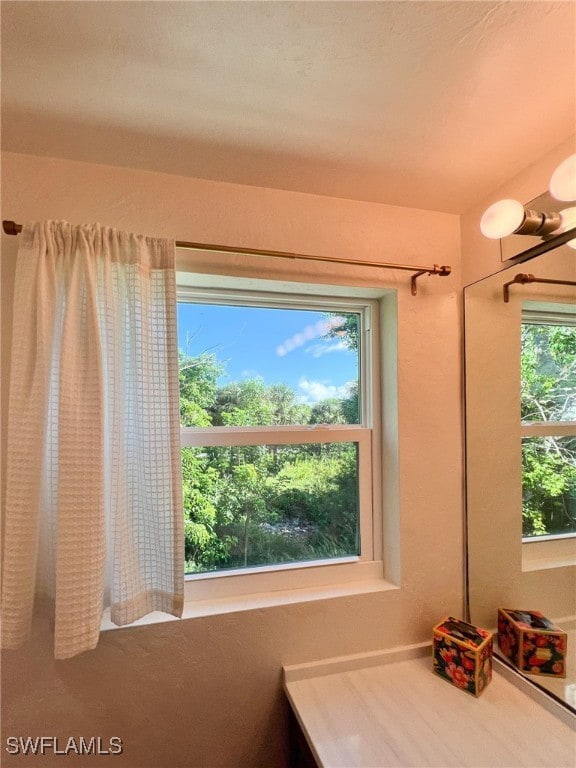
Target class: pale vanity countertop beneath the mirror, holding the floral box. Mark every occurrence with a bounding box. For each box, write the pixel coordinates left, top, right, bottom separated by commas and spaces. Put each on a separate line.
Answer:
284, 647, 576, 768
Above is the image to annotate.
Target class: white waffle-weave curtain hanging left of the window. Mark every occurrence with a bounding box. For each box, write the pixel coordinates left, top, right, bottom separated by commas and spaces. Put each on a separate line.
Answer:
2, 221, 184, 659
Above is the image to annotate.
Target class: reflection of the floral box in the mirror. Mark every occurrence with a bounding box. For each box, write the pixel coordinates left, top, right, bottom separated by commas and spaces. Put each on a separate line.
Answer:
498, 608, 568, 677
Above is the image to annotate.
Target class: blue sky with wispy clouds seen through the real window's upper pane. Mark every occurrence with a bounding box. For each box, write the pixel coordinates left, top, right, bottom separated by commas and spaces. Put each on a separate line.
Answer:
178, 303, 358, 404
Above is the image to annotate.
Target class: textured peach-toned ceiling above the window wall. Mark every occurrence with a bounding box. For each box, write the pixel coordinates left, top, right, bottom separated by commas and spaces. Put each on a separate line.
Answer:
2, 0, 576, 213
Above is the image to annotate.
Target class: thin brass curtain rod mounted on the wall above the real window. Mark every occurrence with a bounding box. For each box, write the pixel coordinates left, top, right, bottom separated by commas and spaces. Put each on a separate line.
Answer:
2, 221, 452, 296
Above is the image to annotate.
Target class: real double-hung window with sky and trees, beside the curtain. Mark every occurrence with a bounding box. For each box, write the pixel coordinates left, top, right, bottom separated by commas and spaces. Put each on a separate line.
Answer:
178, 287, 381, 594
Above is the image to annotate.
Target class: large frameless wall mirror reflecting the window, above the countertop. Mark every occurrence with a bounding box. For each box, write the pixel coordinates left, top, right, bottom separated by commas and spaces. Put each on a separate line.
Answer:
464, 196, 576, 712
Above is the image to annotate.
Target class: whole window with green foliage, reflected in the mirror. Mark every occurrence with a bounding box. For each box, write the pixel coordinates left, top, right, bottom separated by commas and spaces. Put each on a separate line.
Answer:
521, 305, 576, 541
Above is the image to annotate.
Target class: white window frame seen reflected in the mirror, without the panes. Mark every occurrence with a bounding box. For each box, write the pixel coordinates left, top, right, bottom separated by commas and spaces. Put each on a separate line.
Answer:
520, 301, 576, 571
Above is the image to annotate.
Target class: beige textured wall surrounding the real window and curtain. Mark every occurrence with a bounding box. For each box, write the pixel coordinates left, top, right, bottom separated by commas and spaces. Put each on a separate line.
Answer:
2, 154, 463, 768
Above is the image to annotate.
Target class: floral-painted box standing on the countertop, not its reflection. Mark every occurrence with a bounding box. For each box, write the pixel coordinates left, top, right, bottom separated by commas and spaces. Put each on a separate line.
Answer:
432, 616, 492, 696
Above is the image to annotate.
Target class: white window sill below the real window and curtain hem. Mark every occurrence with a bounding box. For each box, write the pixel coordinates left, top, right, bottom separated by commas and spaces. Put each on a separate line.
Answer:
101, 578, 398, 631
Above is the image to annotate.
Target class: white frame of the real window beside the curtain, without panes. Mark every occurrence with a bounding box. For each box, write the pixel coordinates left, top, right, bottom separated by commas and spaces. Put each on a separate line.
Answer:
177, 274, 382, 605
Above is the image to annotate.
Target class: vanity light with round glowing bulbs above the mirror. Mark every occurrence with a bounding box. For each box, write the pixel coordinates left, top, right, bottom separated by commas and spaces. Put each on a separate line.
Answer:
480, 155, 576, 249
